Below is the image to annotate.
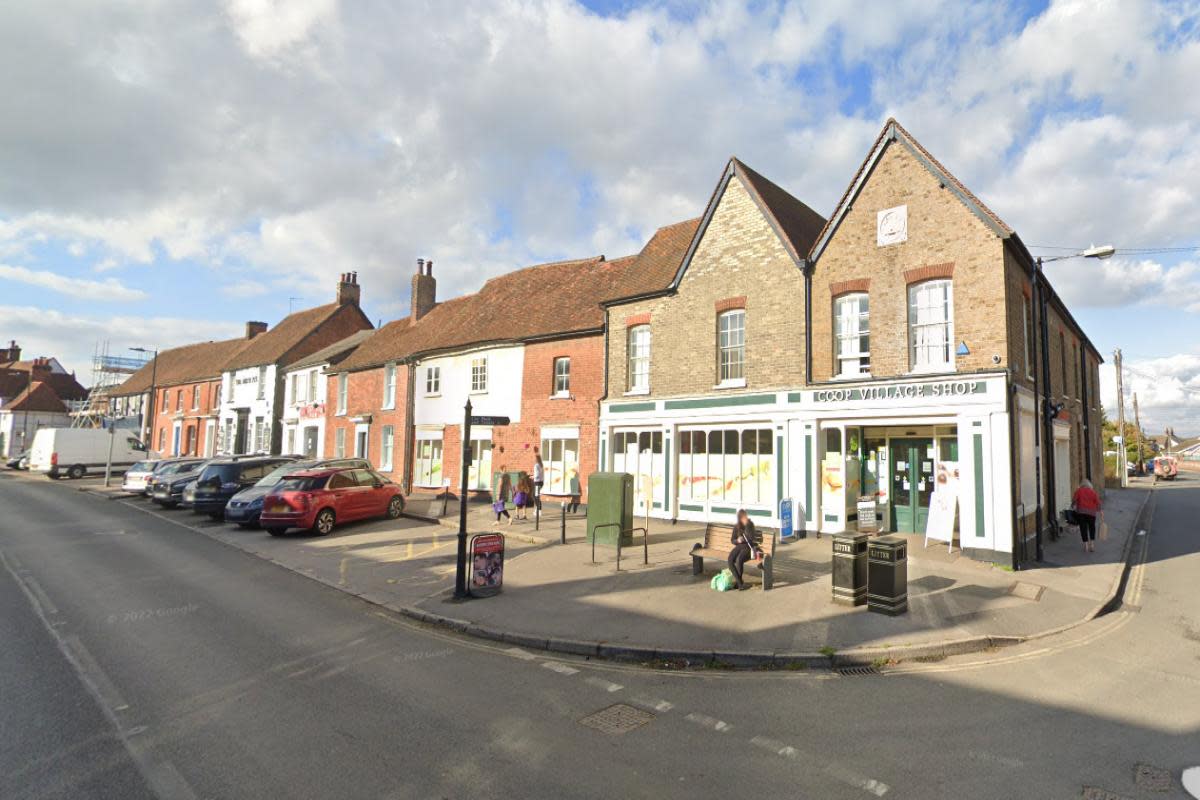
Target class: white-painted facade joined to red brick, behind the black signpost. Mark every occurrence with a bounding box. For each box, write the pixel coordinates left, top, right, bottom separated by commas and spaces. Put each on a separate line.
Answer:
413, 344, 524, 489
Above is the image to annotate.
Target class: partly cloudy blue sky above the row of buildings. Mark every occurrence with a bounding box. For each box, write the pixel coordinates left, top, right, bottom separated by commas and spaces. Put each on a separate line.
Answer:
0, 0, 1200, 435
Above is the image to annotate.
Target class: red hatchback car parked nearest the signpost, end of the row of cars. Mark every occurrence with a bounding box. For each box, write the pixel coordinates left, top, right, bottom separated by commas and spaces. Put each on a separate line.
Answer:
262, 469, 404, 536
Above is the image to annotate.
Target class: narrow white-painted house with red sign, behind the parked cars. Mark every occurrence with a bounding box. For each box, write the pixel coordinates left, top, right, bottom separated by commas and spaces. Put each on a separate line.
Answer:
280, 330, 374, 458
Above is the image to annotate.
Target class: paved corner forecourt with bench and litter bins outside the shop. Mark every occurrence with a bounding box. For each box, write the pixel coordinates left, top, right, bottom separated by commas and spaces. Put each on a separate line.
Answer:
70, 472, 1148, 668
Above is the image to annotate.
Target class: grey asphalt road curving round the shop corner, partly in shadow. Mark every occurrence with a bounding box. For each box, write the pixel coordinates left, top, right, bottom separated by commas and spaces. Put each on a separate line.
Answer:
0, 475, 1200, 800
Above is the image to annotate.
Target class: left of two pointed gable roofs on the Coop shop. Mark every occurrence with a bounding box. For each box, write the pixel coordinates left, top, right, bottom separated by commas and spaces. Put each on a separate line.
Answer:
670, 156, 826, 290
